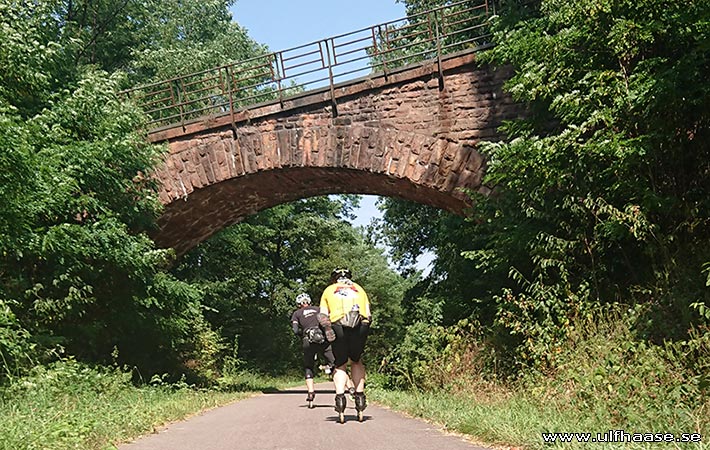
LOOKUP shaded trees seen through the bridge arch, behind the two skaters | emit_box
[176,197,407,373]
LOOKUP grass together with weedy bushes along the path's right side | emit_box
[370,314,710,450]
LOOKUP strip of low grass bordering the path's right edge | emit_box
[369,387,710,450]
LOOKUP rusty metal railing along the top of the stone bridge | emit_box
[121,0,495,130]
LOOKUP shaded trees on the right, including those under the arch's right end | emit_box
[383,0,710,393]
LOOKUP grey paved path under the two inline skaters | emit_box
[119,383,486,450]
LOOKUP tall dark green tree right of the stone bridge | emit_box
[482,0,710,346]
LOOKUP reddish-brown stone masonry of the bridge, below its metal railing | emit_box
[150,54,522,254]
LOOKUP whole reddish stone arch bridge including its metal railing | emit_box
[131,0,522,254]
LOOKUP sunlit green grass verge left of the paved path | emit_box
[0,360,290,450]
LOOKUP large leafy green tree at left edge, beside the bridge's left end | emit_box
[0,2,195,382]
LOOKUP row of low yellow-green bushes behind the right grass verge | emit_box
[377,305,710,437]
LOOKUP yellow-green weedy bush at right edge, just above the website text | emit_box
[523,308,710,432]
